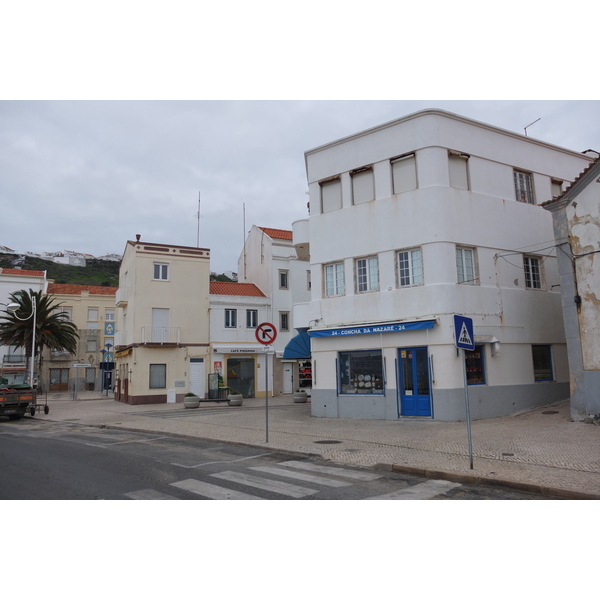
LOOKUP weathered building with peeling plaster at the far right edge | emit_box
[544,158,600,421]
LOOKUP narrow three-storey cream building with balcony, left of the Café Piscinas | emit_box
[115,237,210,404]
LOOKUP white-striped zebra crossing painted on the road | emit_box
[120,460,461,500]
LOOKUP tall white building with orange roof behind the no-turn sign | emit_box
[238,225,311,395]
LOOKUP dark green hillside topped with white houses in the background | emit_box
[0,254,121,287]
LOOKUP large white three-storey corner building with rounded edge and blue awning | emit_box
[298,110,590,421]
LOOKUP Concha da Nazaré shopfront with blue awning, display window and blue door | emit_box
[309,320,435,419]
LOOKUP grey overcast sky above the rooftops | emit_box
[0,100,600,273]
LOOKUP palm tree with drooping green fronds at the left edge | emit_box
[0,289,79,382]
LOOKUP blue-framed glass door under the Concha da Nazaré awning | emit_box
[398,348,431,417]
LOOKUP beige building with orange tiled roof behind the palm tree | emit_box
[41,283,117,392]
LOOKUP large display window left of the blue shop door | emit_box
[339,350,383,394]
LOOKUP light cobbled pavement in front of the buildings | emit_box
[21,392,600,500]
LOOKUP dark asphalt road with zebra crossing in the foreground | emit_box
[0,418,552,500]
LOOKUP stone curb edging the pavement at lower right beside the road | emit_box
[374,463,600,500]
